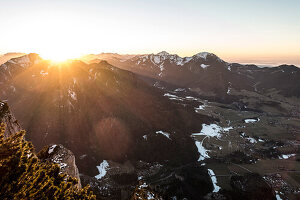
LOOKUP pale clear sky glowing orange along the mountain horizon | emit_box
[0,0,300,65]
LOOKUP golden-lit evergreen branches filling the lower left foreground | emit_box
[0,123,96,200]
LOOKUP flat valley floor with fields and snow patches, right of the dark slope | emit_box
[161,85,300,199]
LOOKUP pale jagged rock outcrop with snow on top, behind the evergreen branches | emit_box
[38,144,81,188]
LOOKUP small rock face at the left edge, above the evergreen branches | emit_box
[0,101,21,138]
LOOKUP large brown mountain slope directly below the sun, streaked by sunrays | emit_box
[0,54,209,174]
